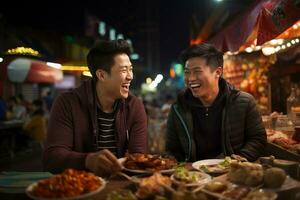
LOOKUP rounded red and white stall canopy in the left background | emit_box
[7,58,63,83]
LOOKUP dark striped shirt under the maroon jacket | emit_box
[97,108,117,155]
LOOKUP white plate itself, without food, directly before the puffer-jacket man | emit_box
[192,159,229,174]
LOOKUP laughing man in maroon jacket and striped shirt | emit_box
[43,40,147,176]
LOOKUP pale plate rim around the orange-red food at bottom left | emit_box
[26,177,106,200]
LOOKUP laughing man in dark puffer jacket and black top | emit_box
[166,44,266,161]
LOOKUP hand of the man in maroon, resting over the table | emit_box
[85,149,122,177]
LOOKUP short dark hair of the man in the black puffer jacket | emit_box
[180,43,223,69]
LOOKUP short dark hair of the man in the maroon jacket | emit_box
[87,39,131,79]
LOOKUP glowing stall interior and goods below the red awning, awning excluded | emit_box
[224,43,300,161]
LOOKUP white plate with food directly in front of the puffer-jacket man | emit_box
[192,157,232,174]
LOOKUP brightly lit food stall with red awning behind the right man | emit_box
[197,0,300,162]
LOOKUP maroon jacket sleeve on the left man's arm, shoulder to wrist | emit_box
[43,96,86,173]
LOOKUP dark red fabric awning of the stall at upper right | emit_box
[207,0,300,52]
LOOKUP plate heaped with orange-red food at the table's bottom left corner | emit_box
[26,169,106,200]
